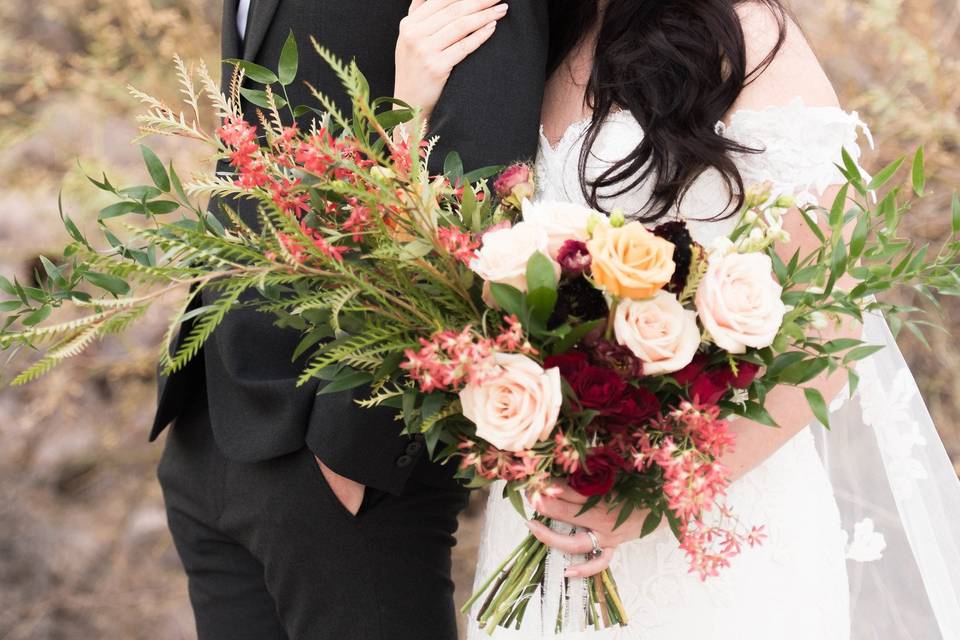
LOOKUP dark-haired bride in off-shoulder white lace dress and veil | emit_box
[456,0,960,640]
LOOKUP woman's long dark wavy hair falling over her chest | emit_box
[549,0,787,222]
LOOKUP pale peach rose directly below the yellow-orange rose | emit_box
[613,291,700,376]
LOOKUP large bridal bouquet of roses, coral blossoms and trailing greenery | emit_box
[0,38,960,633]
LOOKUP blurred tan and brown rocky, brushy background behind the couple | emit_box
[0,0,960,640]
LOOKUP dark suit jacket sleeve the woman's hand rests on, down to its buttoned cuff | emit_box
[307,0,548,492]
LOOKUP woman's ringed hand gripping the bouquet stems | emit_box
[527,483,649,578]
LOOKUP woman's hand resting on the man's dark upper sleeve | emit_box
[394,0,507,119]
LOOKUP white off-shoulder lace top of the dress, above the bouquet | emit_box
[536,98,873,245]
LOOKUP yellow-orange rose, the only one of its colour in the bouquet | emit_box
[587,222,676,299]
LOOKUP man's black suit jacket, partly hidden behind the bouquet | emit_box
[151,0,548,493]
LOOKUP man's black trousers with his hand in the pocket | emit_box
[158,393,467,640]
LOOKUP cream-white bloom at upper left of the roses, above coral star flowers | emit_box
[470,222,560,291]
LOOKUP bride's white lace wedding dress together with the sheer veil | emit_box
[468,100,960,640]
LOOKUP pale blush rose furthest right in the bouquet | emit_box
[696,253,786,353]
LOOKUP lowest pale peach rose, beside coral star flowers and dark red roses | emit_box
[460,353,563,451]
